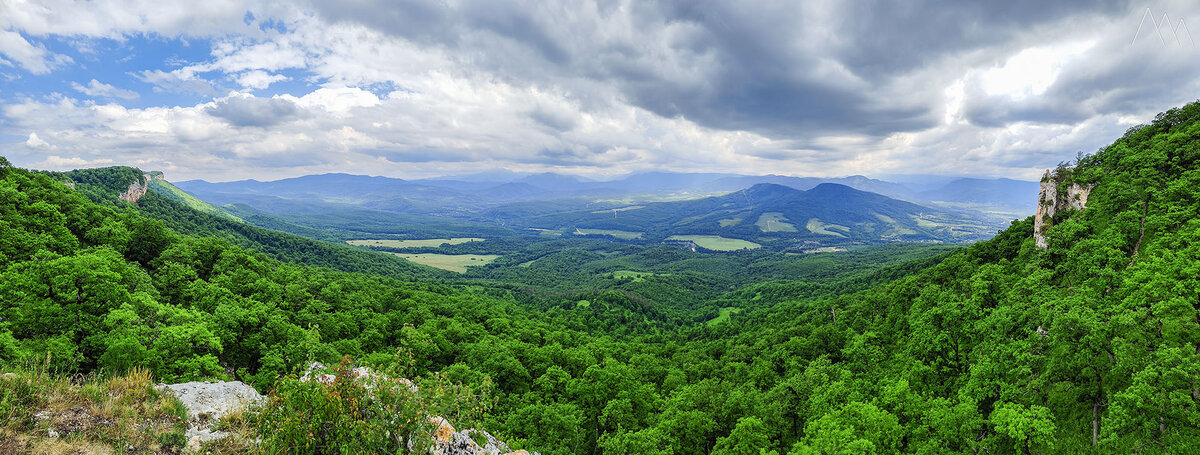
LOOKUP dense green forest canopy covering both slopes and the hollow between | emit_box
[7,99,1200,454]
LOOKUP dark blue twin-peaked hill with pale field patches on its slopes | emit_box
[511,182,1003,245]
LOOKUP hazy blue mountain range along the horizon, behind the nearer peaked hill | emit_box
[175,172,1037,217]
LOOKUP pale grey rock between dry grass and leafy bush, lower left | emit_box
[157,381,265,451]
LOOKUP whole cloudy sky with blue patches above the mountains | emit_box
[0,0,1200,181]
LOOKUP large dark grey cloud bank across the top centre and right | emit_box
[297,0,1128,138]
